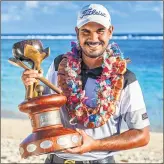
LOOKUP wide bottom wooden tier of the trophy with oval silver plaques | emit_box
[19,127,81,158]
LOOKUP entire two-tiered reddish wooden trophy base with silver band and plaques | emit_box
[19,94,82,158]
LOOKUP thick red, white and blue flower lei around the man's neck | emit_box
[58,42,127,128]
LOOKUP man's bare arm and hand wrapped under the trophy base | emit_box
[65,126,150,154]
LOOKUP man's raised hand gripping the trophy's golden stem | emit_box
[22,69,43,86]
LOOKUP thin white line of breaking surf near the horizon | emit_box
[1,34,163,40]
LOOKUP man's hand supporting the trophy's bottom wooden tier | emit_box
[63,129,99,154]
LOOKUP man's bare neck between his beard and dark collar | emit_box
[82,53,103,69]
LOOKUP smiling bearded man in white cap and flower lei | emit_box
[22,4,149,163]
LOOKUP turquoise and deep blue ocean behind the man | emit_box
[1,34,163,132]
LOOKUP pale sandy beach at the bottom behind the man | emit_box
[1,118,163,163]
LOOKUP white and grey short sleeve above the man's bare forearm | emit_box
[120,80,150,129]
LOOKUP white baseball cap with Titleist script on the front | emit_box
[77,4,111,28]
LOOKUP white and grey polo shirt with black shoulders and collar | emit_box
[45,56,150,161]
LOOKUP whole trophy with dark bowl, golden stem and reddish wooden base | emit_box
[8,40,82,158]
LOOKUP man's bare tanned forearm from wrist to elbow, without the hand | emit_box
[95,129,149,151]
